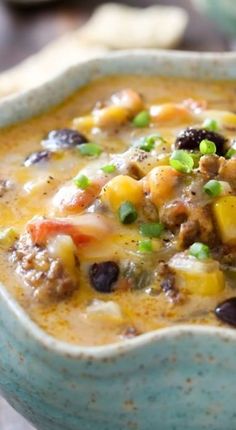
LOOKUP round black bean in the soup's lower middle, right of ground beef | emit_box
[89,261,120,293]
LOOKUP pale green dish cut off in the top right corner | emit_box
[192,0,236,36]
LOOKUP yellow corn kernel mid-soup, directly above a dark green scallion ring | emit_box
[101,175,143,211]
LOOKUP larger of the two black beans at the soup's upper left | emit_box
[42,128,88,151]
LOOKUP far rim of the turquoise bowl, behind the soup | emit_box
[0,49,236,129]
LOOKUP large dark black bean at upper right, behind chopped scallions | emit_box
[175,127,227,155]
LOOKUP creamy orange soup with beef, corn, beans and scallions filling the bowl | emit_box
[0,76,236,345]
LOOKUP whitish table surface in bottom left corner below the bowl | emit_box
[0,397,36,430]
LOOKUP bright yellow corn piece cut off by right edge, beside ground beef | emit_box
[213,196,236,245]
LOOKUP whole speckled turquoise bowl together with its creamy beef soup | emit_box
[0,53,236,430]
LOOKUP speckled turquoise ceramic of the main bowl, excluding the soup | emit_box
[0,51,236,430]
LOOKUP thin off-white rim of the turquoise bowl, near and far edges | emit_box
[0,50,236,360]
